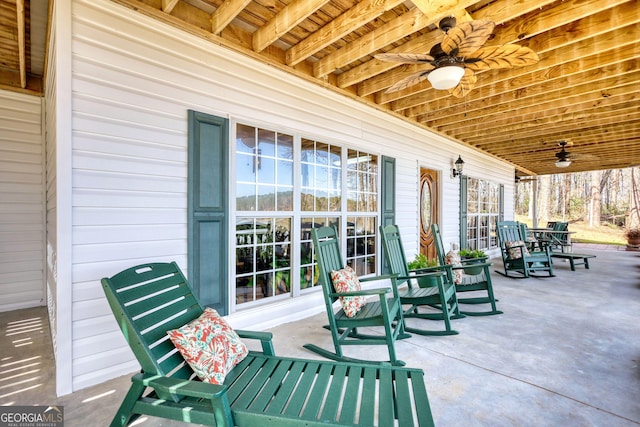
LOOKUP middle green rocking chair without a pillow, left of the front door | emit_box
[380,225,464,335]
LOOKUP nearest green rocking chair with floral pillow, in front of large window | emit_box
[304,227,411,366]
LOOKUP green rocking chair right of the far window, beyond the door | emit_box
[496,221,553,278]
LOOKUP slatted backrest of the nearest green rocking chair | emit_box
[311,227,345,309]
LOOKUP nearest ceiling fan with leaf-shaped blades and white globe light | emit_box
[375,17,539,98]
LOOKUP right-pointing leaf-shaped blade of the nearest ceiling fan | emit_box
[464,44,540,71]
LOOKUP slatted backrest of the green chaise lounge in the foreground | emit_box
[102,262,203,378]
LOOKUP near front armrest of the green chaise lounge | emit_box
[131,373,227,402]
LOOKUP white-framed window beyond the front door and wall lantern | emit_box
[466,178,502,250]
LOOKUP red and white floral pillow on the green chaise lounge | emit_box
[167,307,249,384]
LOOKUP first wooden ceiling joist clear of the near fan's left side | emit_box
[285,0,404,66]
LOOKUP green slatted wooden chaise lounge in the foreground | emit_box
[102,263,433,427]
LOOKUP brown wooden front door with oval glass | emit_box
[420,168,439,259]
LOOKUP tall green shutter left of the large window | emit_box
[187,111,229,315]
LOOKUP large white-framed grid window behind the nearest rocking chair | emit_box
[235,124,379,304]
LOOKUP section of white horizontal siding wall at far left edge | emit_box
[0,90,45,311]
